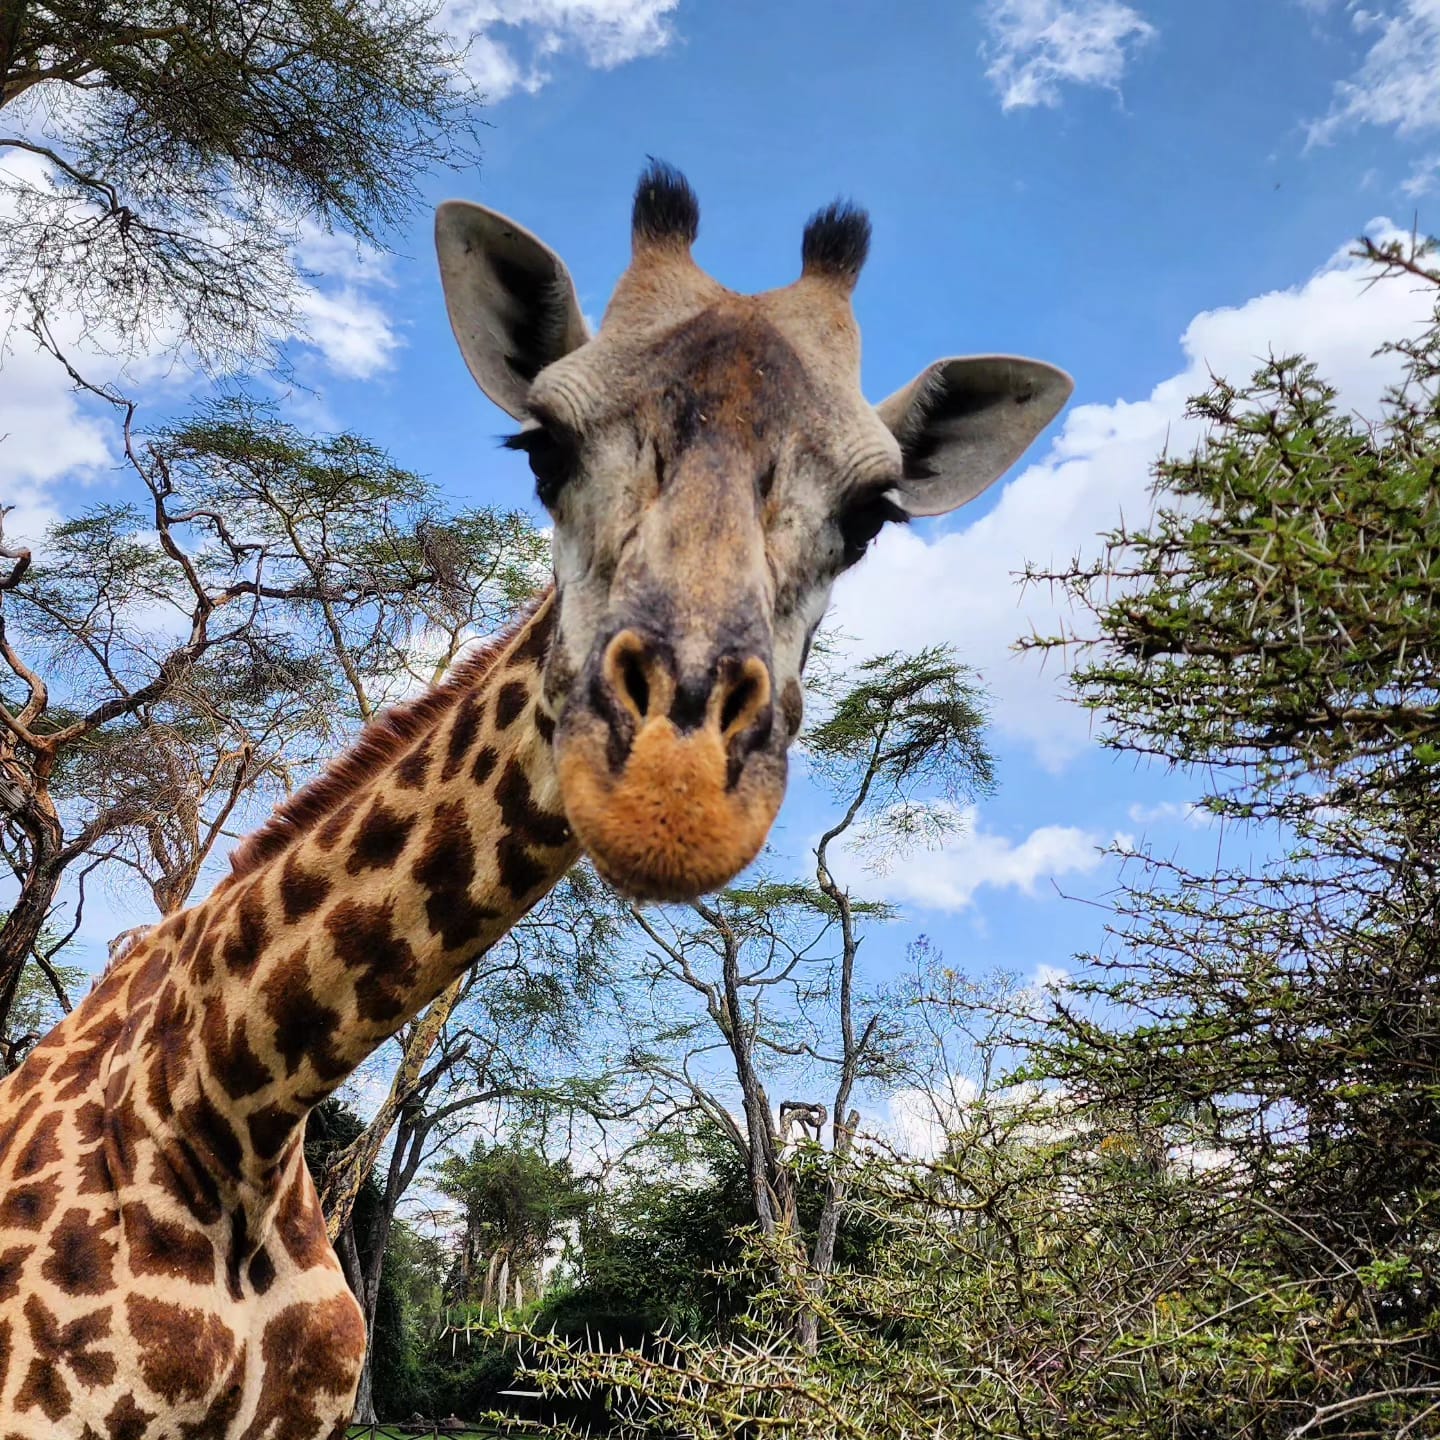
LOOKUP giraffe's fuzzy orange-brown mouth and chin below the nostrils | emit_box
[556,716,785,900]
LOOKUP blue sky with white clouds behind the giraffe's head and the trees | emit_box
[8,0,1440,1019]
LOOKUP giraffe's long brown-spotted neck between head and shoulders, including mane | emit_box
[108,595,577,1200]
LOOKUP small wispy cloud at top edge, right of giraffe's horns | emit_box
[981,0,1155,109]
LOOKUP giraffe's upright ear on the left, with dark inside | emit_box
[435,200,590,419]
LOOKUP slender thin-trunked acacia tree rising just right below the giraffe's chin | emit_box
[613,648,994,1345]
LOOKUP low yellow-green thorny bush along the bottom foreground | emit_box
[521,1106,1221,1440]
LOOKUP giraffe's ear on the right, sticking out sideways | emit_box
[876,356,1074,516]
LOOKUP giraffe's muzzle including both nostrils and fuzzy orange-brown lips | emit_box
[556,629,785,900]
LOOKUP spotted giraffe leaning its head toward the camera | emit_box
[0,163,1070,1440]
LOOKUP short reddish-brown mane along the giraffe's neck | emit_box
[230,590,550,880]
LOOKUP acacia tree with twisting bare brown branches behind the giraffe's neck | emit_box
[0,374,543,1048]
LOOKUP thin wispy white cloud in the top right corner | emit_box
[1309,0,1440,144]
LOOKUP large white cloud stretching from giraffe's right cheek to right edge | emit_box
[835,222,1431,770]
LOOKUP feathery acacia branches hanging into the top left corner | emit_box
[0,0,474,367]
